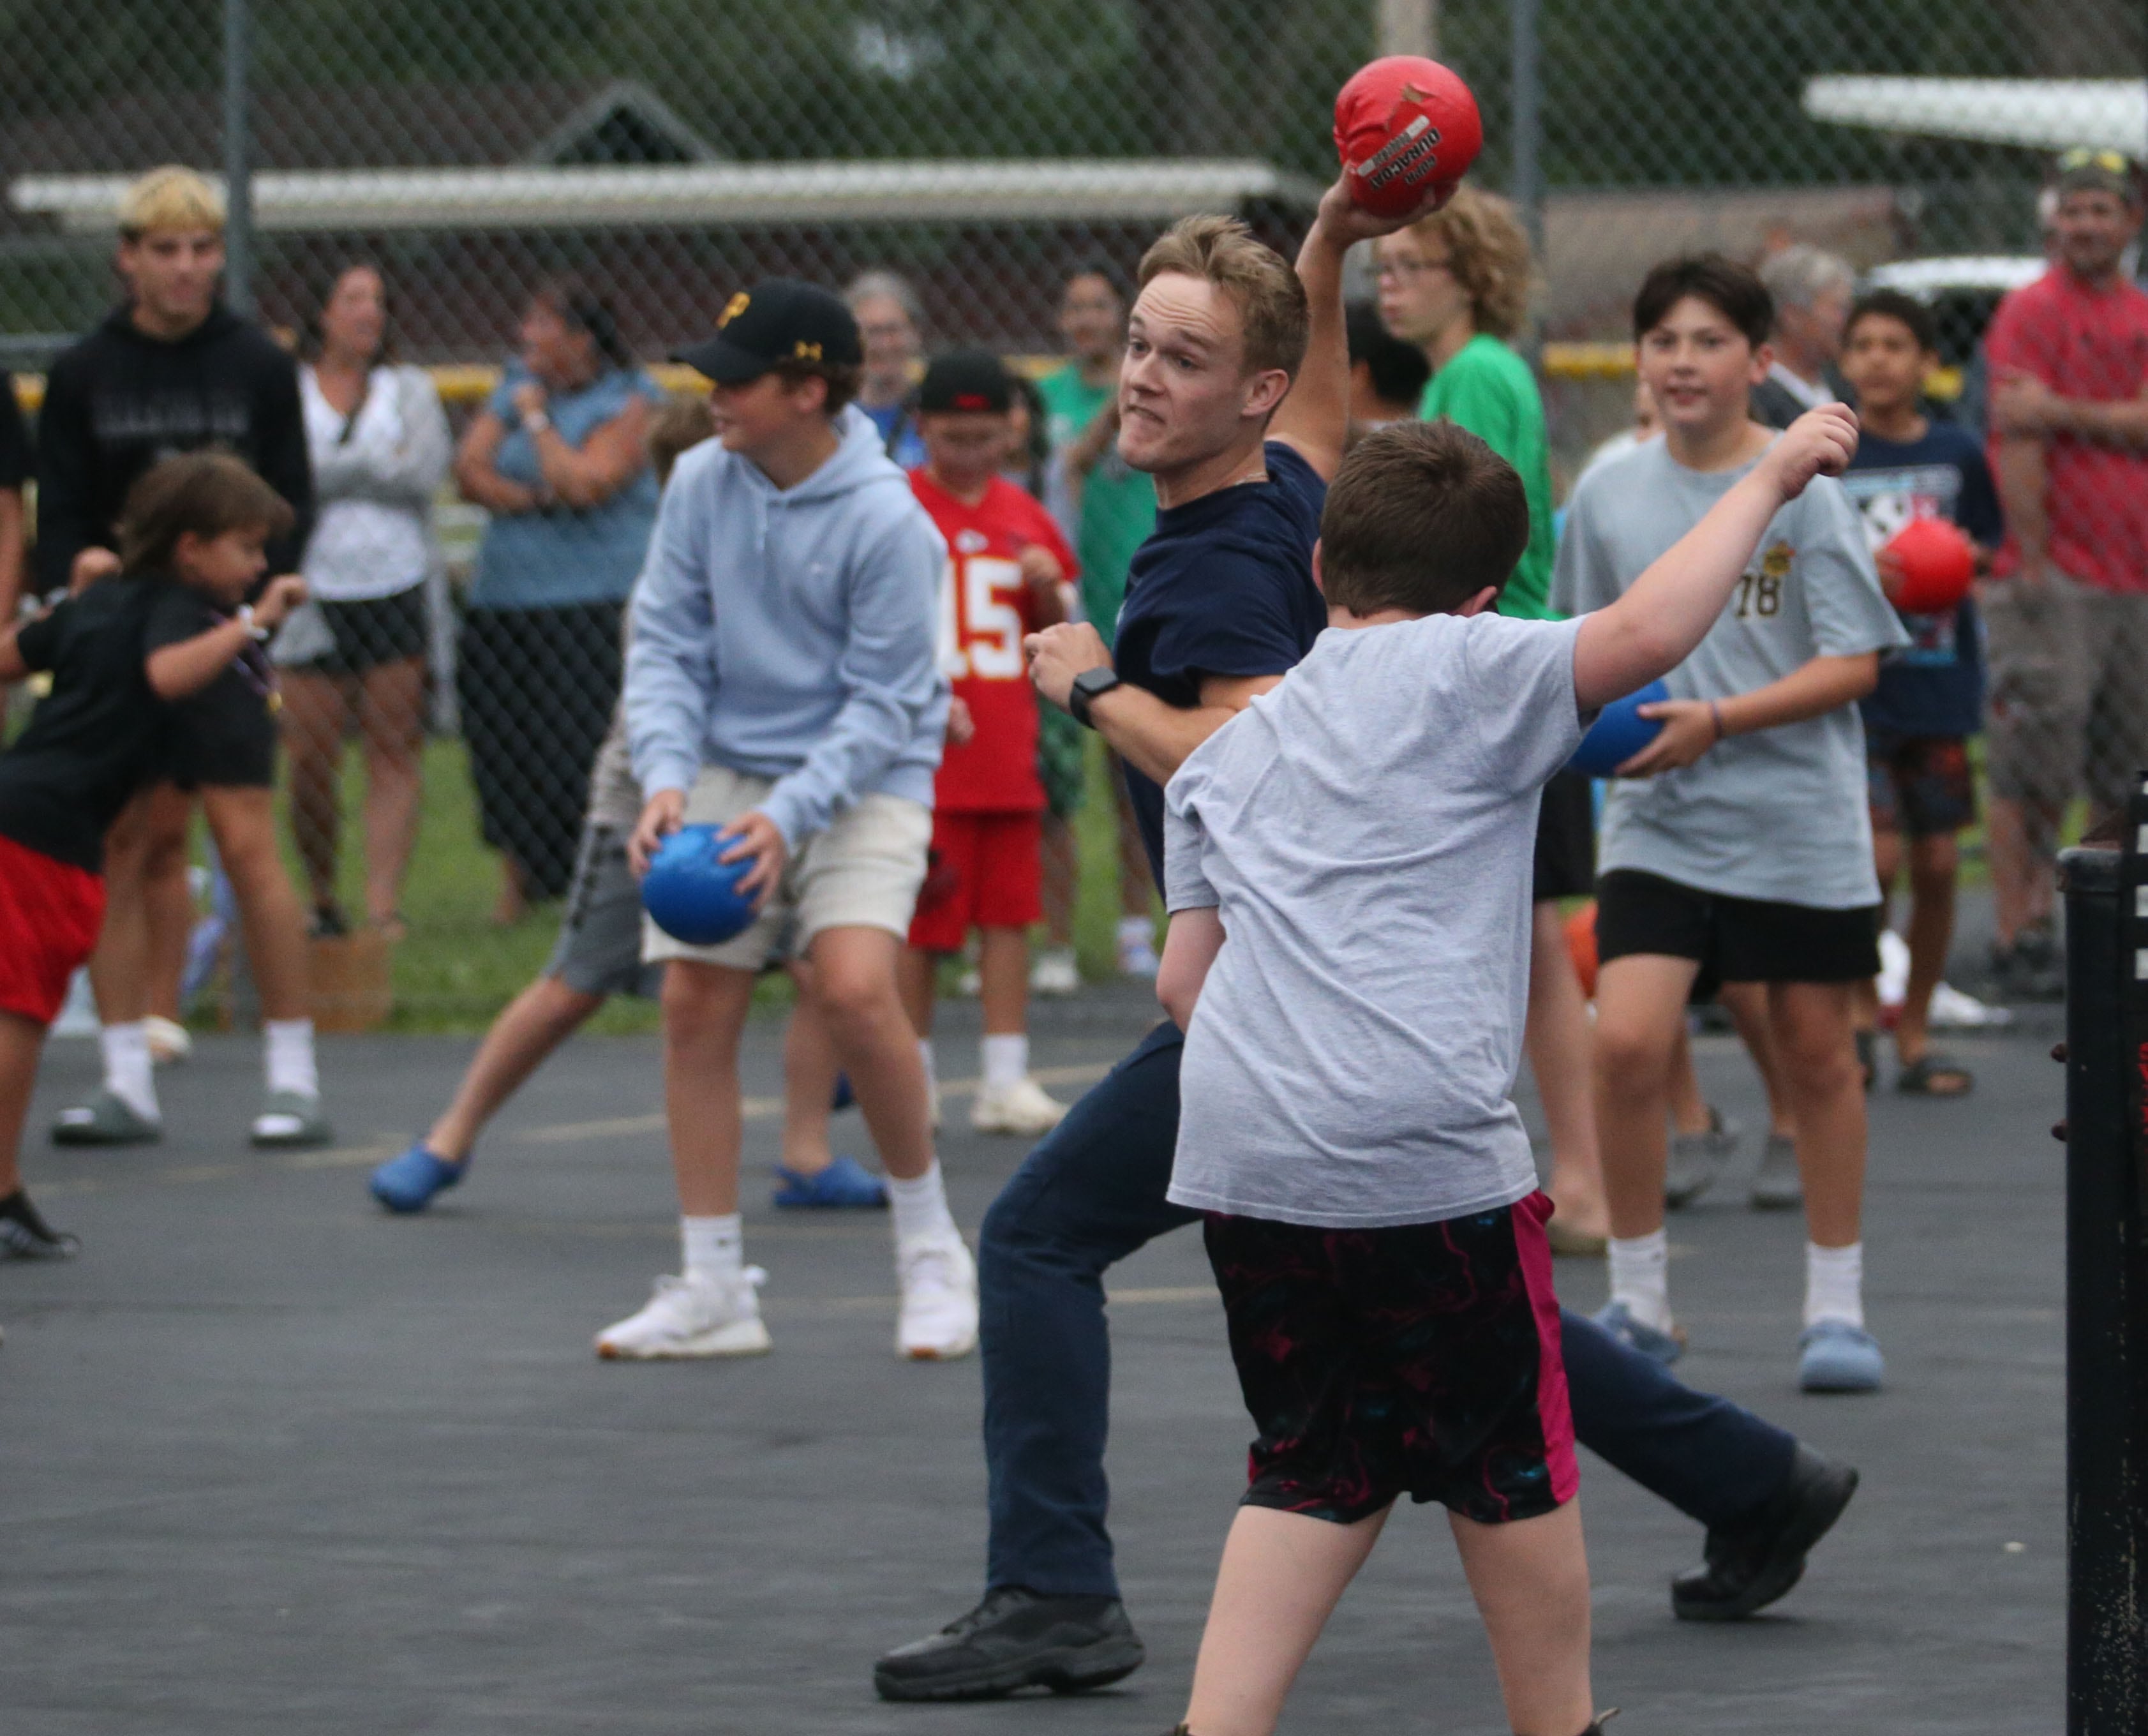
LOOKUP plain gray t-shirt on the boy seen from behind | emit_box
[1164,615,1581,1229]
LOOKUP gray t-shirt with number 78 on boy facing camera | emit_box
[1551,440,1907,911]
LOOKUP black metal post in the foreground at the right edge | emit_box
[2060,825,2148,1736]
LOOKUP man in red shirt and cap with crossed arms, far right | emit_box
[1985,151,2148,995]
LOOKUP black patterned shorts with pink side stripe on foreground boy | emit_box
[1203,1192,1577,1525]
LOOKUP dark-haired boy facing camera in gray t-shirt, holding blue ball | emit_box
[1553,256,1907,1392]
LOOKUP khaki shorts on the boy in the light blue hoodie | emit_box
[642,765,932,971]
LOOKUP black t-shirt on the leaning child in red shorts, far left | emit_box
[0,578,176,872]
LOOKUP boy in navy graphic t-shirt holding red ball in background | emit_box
[1843,290,2002,1098]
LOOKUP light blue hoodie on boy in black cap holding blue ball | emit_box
[625,406,947,851]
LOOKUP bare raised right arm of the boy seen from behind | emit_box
[1574,404,1858,711]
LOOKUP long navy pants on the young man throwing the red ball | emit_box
[978,1022,1796,1596]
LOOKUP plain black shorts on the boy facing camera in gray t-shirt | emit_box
[1596,868,1879,999]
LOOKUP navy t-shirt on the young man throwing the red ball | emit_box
[1113,440,1327,885]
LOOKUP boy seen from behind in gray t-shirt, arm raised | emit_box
[1158,406,1856,1736]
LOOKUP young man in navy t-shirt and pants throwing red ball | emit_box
[874,185,1856,1700]
